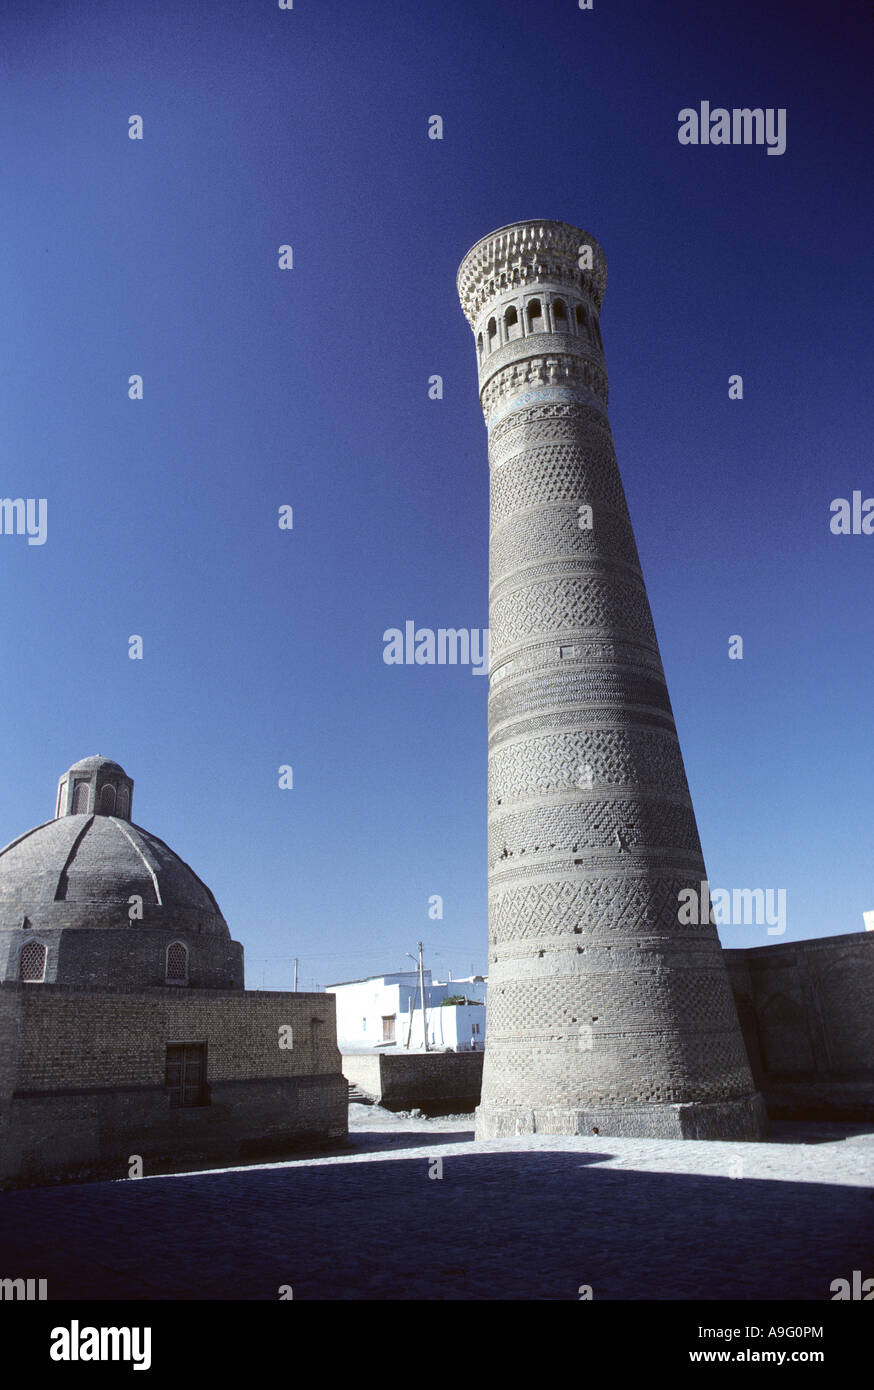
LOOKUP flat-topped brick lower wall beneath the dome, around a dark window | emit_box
[0,983,347,1184]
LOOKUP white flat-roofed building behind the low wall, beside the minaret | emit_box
[325,970,485,1052]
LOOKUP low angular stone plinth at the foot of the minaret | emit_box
[475,1091,767,1140]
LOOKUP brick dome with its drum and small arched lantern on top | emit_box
[0,756,243,990]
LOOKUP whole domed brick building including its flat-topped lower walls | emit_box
[0,755,347,1186]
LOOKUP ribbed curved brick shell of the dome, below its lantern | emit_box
[0,811,231,940]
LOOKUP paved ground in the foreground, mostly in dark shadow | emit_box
[0,1106,874,1300]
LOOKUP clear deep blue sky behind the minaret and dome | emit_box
[0,0,874,987]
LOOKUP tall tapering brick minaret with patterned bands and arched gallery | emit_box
[459,221,764,1138]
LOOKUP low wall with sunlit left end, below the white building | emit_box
[343,1051,484,1115]
